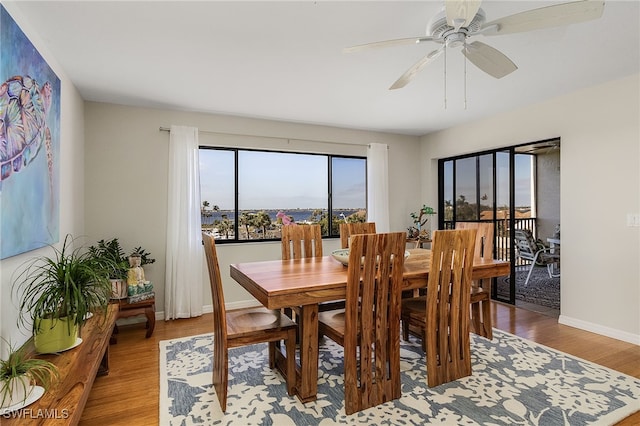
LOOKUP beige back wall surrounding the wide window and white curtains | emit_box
[85,102,422,316]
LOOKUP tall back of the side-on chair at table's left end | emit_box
[202,232,229,410]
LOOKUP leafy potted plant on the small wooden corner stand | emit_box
[89,238,156,299]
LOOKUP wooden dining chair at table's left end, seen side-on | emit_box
[202,232,297,412]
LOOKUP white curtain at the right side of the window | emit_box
[367,143,389,232]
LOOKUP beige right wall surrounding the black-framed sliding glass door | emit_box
[422,75,640,344]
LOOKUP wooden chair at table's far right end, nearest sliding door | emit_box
[456,222,494,339]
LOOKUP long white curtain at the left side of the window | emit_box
[164,126,203,320]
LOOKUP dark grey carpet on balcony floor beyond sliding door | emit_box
[496,266,560,310]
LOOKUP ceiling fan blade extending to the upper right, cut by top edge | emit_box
[481,0,604,36]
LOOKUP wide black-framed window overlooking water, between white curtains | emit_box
[200,147,367,242]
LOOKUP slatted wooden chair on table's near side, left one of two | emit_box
[318,232,406,414]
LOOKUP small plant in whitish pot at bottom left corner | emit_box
[0,344,59,408]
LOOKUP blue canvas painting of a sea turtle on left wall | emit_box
[0,5,60,259]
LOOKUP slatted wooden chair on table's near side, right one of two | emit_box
[401,229,477,387]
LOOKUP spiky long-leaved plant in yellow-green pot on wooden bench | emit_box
[13,235,114,353]
